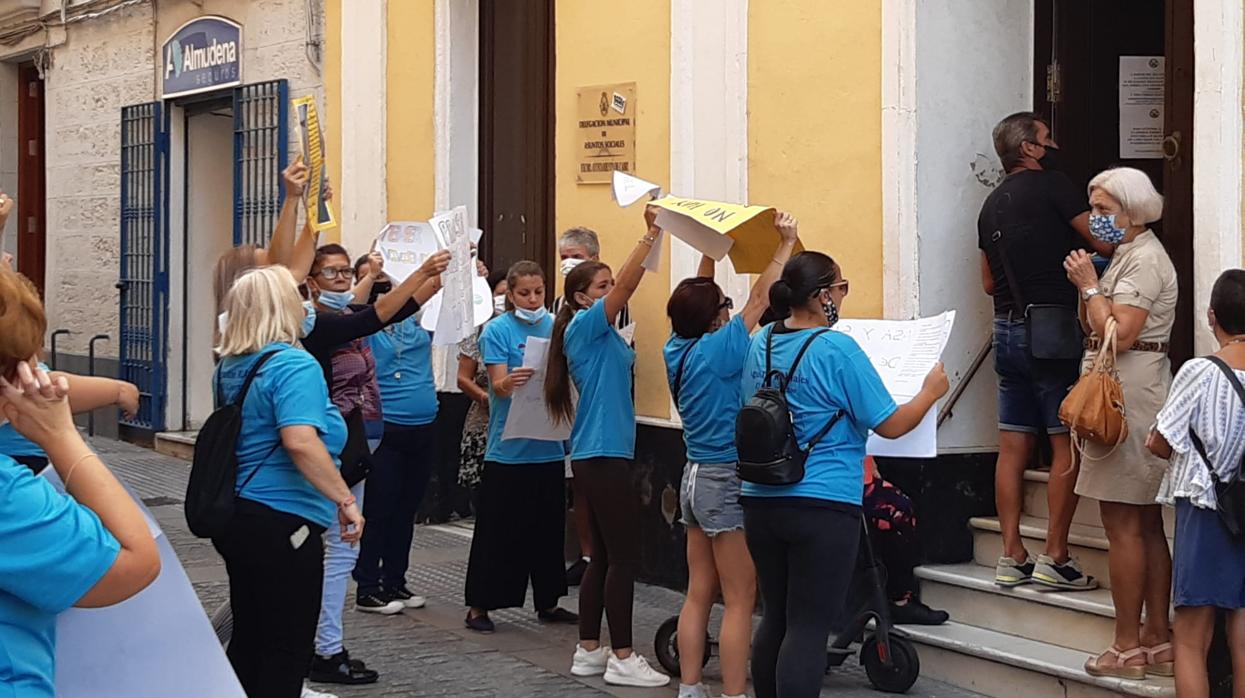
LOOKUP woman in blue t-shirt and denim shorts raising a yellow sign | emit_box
[665,212,798,698]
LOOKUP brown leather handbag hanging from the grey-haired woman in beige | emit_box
[1059,317,1128,454]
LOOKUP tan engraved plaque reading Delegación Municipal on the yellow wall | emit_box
[575,82,635,184]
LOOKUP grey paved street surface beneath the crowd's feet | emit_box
[92,439,976,698]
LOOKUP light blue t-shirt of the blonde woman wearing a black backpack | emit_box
[214,343,346,528]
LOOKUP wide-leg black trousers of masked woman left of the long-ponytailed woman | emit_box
[466,460,566,611]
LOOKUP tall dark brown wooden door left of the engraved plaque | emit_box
[479,0,554,274]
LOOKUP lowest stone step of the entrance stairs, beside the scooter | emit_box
[903,621,1175,698]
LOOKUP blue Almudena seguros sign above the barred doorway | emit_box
[161,16,242,100]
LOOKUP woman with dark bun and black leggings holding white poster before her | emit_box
[737,253,947,698]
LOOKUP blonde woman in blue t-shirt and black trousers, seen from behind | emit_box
[212,266,364,698]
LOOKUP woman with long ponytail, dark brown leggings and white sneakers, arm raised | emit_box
[544,205,670,687]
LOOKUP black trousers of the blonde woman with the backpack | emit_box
[212,500,324,698]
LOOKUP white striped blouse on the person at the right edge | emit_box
[1157,358,1245,509]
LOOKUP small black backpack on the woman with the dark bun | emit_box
[735,325,843,485]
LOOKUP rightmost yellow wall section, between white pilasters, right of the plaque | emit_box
[748,0,883,317]
